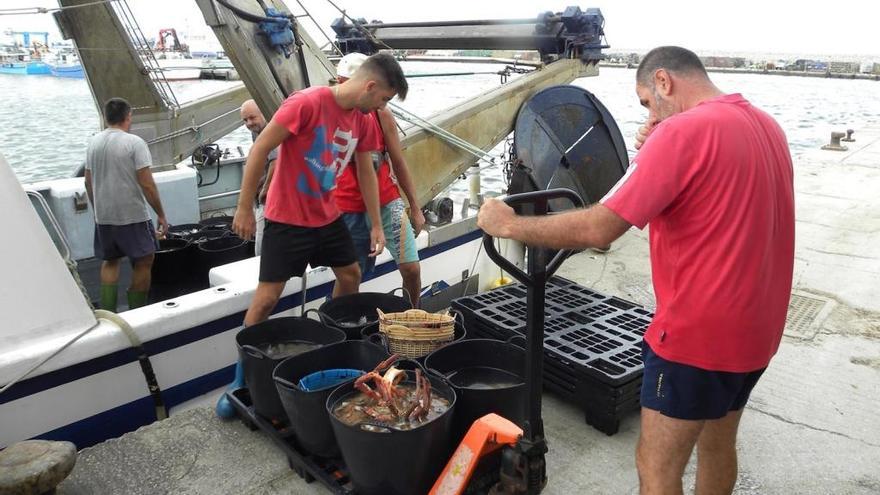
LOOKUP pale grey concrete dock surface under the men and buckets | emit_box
[58,129,880,495]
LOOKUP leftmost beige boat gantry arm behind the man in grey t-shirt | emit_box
[53,0,249,166]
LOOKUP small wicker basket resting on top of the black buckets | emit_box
[378,309,455,358]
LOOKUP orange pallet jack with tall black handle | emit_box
[430,189,583,495]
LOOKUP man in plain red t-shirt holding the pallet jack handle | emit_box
[478,47,794,493]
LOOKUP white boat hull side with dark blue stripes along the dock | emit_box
[0,231,482,449]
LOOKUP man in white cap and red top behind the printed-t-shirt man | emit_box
[333,53,425,308]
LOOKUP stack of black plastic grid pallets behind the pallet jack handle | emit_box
[452,277,653,435]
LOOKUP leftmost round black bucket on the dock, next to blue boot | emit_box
[235,316,345,423]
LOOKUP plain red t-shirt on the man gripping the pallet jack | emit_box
[601,94,794,372]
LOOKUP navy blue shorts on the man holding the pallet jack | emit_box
[641,342,766,420]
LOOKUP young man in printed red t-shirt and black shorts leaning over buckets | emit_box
[217,54,408,417]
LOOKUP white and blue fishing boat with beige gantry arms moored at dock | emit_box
[0,0,625,454]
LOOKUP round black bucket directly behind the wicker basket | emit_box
[318,292,412,340]
